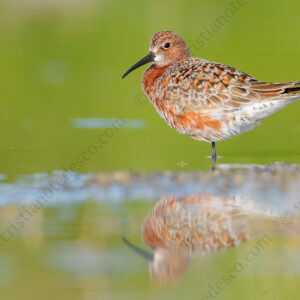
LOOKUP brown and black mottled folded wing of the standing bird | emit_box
[162,58,300,111]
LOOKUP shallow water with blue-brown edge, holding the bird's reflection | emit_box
[0,164,300,299]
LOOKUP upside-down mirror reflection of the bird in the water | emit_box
[124,195,292,283]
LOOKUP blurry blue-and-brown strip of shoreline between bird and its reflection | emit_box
[0,163,300,217]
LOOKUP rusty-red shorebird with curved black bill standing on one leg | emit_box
[122,31,300,171]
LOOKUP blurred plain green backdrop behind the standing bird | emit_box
[0,0,300,178]
